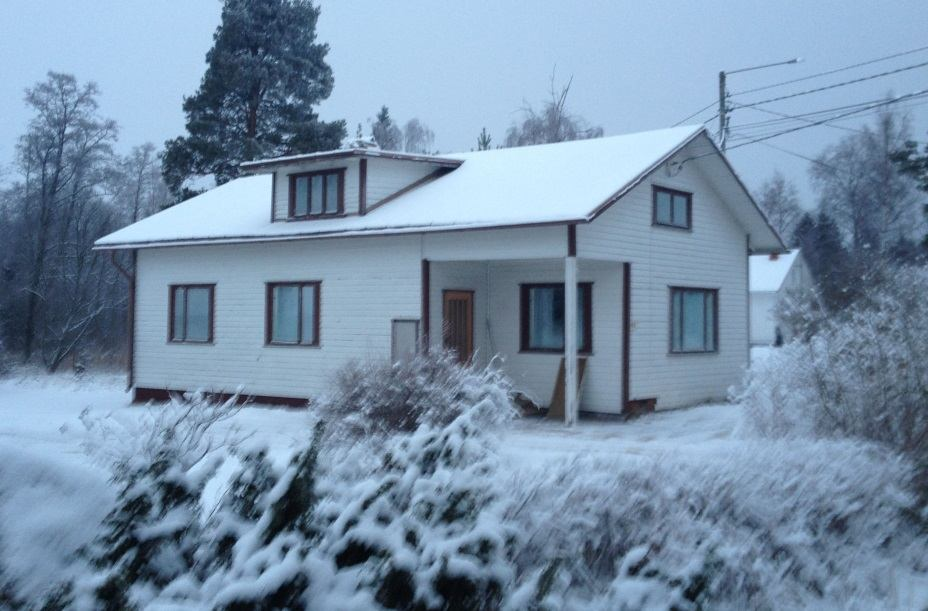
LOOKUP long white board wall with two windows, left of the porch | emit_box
[135,236,421,397]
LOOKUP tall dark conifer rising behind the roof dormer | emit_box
[162,0,346,196]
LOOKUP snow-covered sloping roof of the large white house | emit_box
[96,126,779,248]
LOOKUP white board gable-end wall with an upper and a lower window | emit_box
[577,142,748,409]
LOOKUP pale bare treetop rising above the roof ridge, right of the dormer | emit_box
[505,74,603,147]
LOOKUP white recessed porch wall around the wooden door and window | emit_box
[429,258,622,414]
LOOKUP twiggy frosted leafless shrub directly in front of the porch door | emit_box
[319,351,510,437]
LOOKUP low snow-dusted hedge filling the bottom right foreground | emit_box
[509,441,928,610]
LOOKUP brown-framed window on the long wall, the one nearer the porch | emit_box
[266,281,320,346]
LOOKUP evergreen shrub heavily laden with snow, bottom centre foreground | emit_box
[320,390,514,609]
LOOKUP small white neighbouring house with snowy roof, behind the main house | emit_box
[750,248,814,346]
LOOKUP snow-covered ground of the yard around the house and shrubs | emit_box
[0,373,928,609]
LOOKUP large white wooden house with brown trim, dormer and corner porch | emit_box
[96,127,784,418]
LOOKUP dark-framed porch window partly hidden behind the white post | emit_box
[521,282,593,352]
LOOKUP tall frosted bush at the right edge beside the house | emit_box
[735,267,928,466]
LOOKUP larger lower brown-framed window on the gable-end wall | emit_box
[670,287,719,353]
